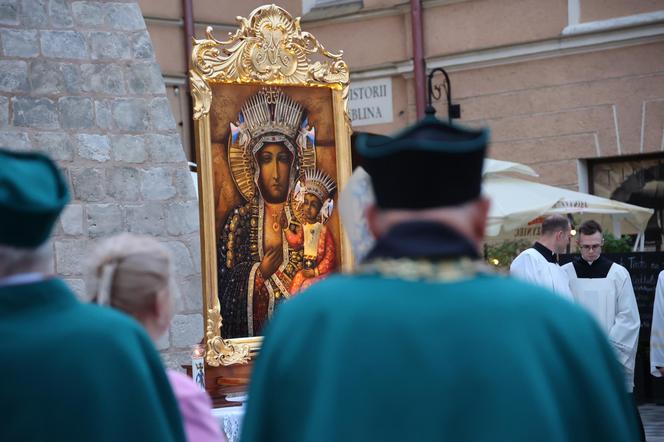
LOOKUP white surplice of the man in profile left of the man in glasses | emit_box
[510,248,572,301]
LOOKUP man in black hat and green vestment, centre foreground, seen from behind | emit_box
[242,112,638,442]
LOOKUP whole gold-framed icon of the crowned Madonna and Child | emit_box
[190,5,351,366]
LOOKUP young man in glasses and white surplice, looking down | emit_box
[563,220,645,440]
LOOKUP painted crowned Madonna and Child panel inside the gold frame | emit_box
[210,84,341,338]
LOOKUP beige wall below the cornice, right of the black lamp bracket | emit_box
[460,42,664,187]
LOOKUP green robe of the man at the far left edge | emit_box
[0,279,185,442]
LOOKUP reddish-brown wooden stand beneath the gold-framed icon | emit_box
[182,359,253,408]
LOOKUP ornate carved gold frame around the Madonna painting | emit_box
[189,5,352,367]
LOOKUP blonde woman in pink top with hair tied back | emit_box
[88,233,226,442]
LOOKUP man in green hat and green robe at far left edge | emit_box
[0,149,185,442]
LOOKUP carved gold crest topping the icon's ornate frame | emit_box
[191,5,349,119]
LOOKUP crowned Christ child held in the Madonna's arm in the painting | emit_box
[286,169,336,296]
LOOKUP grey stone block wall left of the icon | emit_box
[0,0,203,367]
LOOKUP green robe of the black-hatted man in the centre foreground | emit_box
[242,274,639,442]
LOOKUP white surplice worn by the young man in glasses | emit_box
[562,263,641,392]
